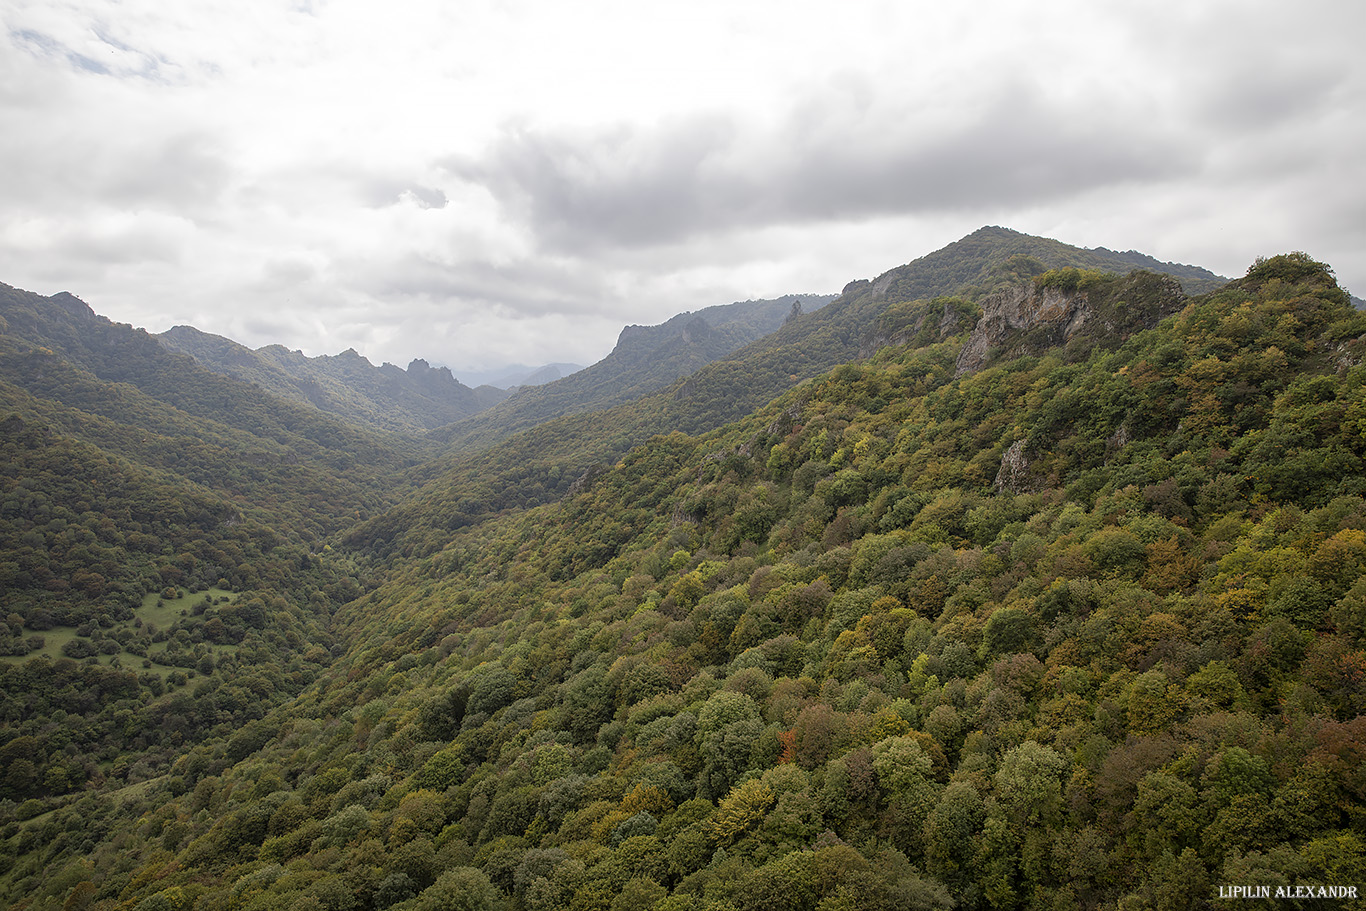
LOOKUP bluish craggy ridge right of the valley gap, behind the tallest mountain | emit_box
[430,295,833,449]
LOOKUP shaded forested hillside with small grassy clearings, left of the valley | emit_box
[0,287,422,846]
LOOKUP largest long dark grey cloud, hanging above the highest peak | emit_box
[445,85,1197,250]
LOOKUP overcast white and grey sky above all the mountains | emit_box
[0,0,1366,376]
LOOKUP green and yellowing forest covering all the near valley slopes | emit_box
[0,228,1366,911]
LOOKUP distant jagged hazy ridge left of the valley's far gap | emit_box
[156,326,505,433]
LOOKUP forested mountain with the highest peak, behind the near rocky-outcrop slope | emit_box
[351,227,1229,550]
